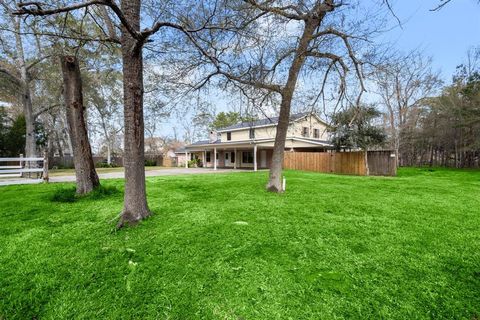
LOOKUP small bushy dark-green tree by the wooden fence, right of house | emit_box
[330,105,386,175]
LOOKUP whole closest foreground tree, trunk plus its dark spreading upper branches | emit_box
[15,0,216,227]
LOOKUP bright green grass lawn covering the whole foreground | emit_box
[0,169,480,320]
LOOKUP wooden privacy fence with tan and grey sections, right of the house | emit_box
[283,151,396,176]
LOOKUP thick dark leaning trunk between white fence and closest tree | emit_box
[61,56,100,194]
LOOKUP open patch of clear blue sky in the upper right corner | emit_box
[379,0,480,81]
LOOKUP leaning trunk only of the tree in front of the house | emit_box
[267,16,323,192]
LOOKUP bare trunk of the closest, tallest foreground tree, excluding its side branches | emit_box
[117,0,150,228]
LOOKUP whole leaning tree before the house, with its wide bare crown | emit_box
[181,0,375,192]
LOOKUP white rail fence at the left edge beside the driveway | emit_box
[0,155,48,182]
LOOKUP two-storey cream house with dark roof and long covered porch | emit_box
[182,113,332,170]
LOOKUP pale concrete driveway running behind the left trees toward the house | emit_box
[0,168,240,186]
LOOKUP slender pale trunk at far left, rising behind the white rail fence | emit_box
[12,17,37,158]
